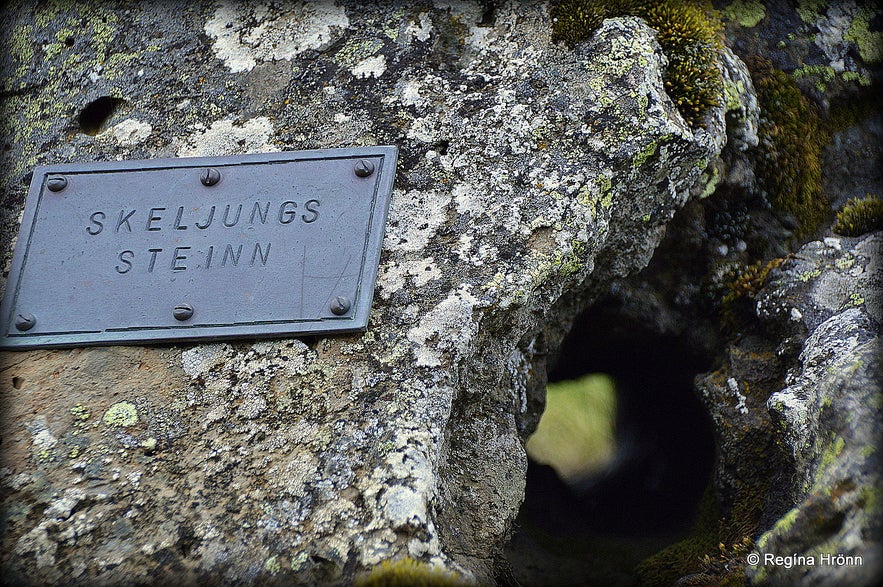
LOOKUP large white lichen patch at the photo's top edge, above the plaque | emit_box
[205,1,349,73]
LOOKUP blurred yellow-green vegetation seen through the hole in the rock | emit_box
[527,373,616,482]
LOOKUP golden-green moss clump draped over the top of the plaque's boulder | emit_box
[551,0,723,127]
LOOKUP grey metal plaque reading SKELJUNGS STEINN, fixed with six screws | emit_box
[0,146,398,349]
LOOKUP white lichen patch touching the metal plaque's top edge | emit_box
[177,116,279,157]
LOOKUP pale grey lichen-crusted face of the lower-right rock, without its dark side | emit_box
[750,232,883,585]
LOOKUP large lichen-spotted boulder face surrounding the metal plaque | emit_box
[0,2,736,584]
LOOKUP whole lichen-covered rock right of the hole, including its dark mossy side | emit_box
[698,232,883,585]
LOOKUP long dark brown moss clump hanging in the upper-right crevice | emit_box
[746,57,828,236]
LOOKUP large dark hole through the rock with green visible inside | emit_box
[507,302,715,585]
